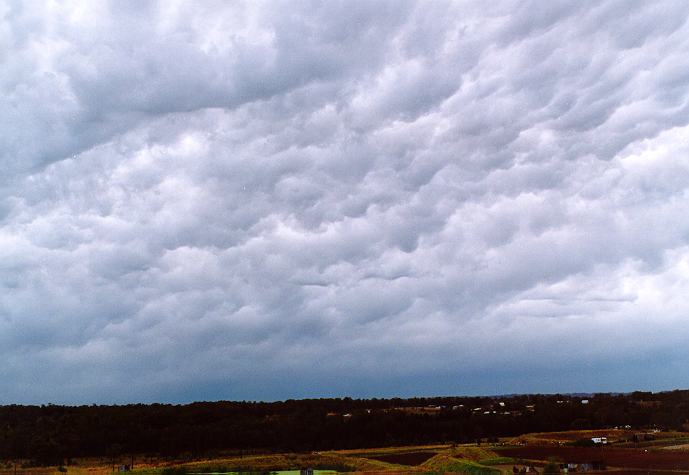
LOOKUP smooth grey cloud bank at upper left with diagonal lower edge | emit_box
[2,2,407,180]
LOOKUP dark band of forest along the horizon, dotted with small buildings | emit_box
[0,390,689,465]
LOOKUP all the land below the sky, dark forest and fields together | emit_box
[0,391,689,475]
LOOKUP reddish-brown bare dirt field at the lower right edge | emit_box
[499,446,689,473]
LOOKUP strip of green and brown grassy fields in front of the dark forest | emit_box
[5,429,689,475]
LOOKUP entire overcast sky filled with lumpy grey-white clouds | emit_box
[0,0,689,404]
